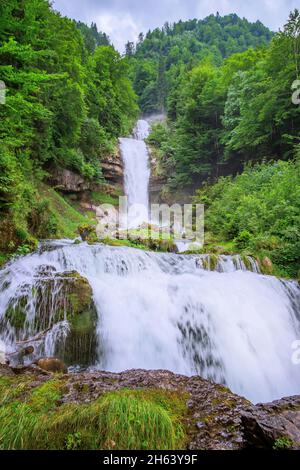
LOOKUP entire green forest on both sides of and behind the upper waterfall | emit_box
[0,0,300,276]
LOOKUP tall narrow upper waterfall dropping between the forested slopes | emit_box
[120,120,150,228]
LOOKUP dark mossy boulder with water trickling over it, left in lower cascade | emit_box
[0,266,97,366]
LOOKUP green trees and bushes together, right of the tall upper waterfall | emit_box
[144,10,300,276]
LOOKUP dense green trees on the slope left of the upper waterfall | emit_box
[0,0,138,258]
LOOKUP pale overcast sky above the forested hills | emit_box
[53,0,299,52]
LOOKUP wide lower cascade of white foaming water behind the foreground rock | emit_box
[0,241,300,402]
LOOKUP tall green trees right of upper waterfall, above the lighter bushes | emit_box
[145,10,300,190]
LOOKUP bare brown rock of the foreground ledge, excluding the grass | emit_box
[0,366,300,450]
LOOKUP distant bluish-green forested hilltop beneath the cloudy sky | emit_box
[127,15,272,113]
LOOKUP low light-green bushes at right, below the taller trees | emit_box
[195,157,300,277]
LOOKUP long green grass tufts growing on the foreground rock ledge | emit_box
[0,377,187,450]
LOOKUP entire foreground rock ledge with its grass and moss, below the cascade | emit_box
[0,366,300,450]
